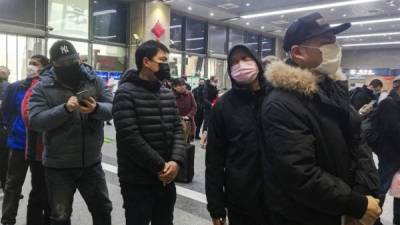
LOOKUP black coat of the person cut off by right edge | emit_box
[376,91,400,165]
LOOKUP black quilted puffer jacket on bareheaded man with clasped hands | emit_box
[113,70,184,184]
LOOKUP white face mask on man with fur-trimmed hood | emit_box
[303,43,342,75]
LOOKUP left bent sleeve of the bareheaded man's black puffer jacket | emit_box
[113,91,165,173]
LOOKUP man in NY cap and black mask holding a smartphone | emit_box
[29,40,112,225]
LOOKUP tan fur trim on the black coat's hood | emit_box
[265,61,346,96]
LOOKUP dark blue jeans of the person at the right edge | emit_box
[378,160,400,223]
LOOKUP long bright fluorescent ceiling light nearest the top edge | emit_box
[240,0,382,19]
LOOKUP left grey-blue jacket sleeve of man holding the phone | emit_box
[29,84,73,132]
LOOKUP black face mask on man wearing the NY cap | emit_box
[54,63,82,89]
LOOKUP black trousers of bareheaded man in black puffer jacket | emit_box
[121,183,176,225]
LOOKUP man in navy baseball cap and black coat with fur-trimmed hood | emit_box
[261,13,381,225]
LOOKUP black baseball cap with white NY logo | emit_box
[50,40,79,63]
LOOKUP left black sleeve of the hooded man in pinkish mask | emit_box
[206,103,228,218]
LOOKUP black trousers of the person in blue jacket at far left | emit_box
[1,150,28,224]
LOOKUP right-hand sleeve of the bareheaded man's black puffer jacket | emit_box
[171,99,185,165]
